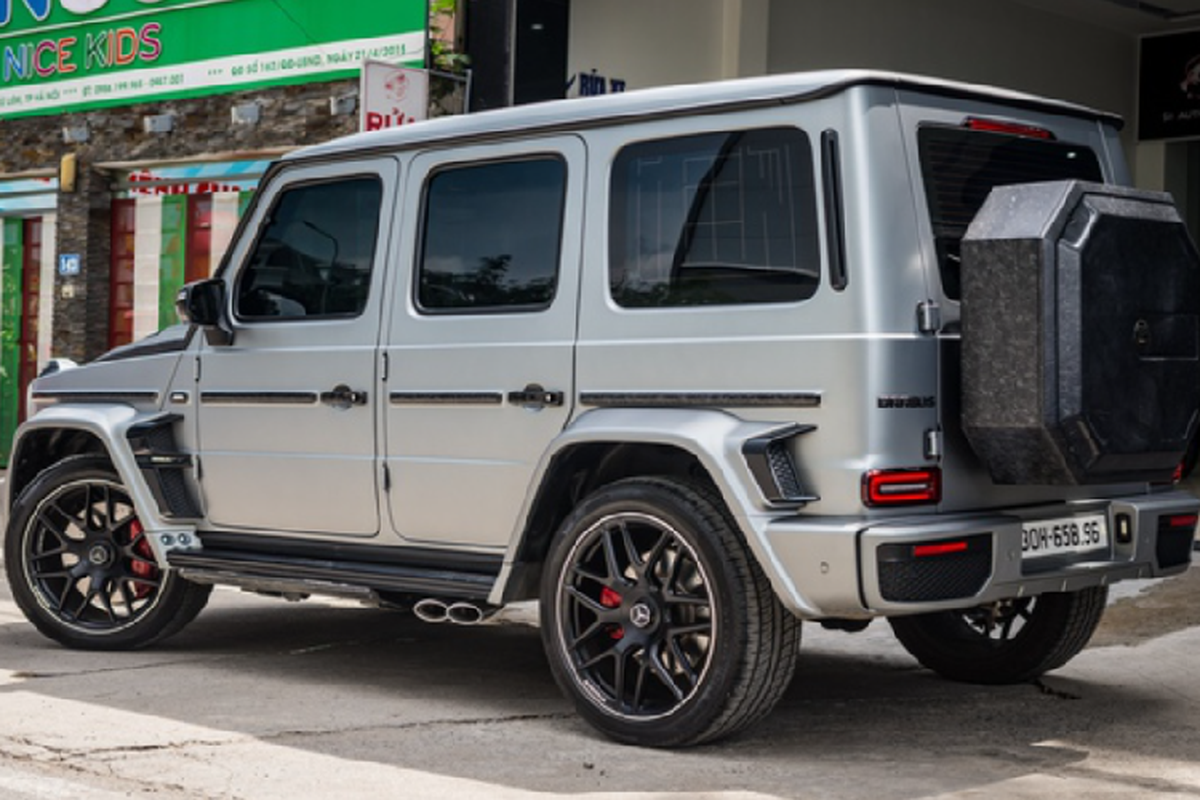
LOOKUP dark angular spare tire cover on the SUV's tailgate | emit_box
[962,181,1200,485]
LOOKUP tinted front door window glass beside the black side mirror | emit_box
[235,178,383,319]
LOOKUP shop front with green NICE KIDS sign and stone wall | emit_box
[0,0,428,467]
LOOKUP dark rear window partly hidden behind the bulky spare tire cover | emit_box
[917,125,1103,300]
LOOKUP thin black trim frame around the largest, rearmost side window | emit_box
[604,122,826,313]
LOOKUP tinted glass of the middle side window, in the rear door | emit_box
[416,156,566,313]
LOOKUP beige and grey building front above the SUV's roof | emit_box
[568,0,1200,209]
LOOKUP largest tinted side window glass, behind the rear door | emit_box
[608,127,821,307]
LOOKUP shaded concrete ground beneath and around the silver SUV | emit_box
[0,571,1200,800]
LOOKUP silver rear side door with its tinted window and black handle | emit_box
[384,137,584,548]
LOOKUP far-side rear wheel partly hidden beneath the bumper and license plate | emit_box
[888,587,1108,684]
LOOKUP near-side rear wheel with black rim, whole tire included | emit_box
[541,479,800,747]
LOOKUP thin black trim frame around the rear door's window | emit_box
[409,150,571,318]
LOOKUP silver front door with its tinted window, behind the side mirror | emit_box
[197,158,397,536]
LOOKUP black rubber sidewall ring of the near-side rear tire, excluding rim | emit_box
[540,480,748,746]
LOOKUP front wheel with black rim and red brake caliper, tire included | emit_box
[4,456,212,650]
